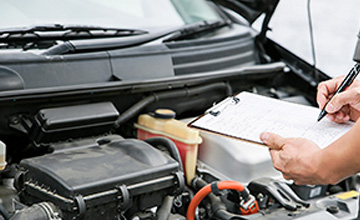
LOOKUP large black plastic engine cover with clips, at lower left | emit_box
[15,139,183,220]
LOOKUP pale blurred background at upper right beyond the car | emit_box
[255,0,360,77]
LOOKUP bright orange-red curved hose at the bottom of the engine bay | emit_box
[186,181,255,220]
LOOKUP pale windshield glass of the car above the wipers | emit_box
[0,0,220,31]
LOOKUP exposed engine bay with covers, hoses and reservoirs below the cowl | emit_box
[2,68,358,219]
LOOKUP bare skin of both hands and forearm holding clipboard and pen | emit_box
[260,77,360,185]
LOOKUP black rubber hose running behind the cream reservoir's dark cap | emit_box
[114,82,232,128]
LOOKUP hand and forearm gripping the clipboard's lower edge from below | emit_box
[260,120,360,185]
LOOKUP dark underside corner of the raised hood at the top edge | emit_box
[212,0,279,24]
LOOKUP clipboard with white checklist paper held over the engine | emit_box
[188,92,353,148]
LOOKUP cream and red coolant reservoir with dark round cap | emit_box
[135,109,202,184]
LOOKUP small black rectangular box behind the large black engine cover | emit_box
[29,102,119,144]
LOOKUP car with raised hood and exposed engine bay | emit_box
[0,0,359,220]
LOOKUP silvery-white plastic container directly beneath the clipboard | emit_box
[198,132,281,184]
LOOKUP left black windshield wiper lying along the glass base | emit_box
[0,24,148,42]
